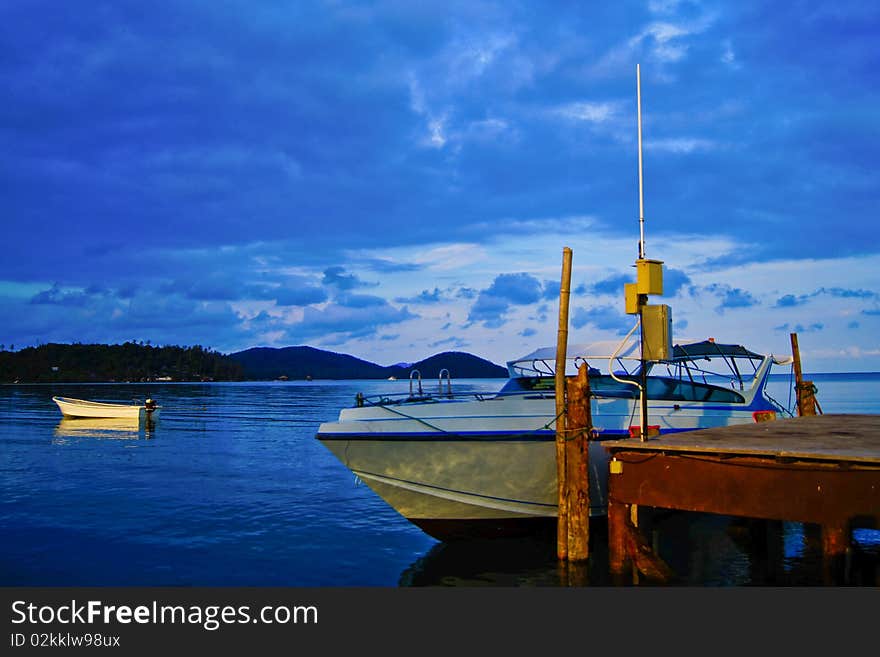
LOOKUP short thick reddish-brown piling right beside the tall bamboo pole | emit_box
[565,363,593,561]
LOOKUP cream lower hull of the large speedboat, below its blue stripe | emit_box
[321,434,608,539]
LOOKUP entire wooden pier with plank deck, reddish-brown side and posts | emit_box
[603,415,880,584]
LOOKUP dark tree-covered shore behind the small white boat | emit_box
[0,342,244,383]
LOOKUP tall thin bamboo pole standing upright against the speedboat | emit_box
[555,246,571,560]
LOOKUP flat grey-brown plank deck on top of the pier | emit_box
[602,415,880,465]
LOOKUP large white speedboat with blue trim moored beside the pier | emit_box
[317,340,791,539]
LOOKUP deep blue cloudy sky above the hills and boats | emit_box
[0,0,880,375]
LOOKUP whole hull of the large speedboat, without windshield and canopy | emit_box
[317,398,754,540]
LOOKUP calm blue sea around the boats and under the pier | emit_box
[0,375,880,586]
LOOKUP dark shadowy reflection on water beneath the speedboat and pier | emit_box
[398,510,880,586]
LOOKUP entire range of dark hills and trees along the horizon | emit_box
[0,342,507,383]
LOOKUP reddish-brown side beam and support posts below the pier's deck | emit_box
[608,441,880,584]
